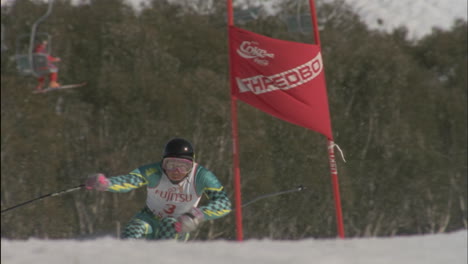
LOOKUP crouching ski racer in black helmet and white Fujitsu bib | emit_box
[86,138,231,240]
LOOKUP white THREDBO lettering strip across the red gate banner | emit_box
[236,51,323,94]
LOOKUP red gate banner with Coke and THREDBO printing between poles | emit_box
[229,26,333,139]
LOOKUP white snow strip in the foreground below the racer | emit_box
[1,230,467,264]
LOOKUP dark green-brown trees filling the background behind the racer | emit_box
[1,0,468,240]
